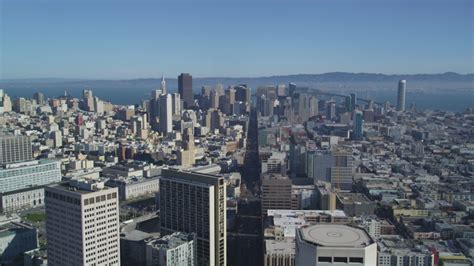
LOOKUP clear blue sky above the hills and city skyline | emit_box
[0,0,474,79]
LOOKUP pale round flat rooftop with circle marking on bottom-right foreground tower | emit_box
[300,224,373,247]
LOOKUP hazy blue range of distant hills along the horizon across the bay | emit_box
[0,72,474,94]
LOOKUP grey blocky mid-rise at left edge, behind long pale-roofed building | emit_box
[0,136,33,165]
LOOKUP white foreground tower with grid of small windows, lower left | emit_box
[45,180,120,266]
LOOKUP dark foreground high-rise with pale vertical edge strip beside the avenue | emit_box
[160,169,227,266]
